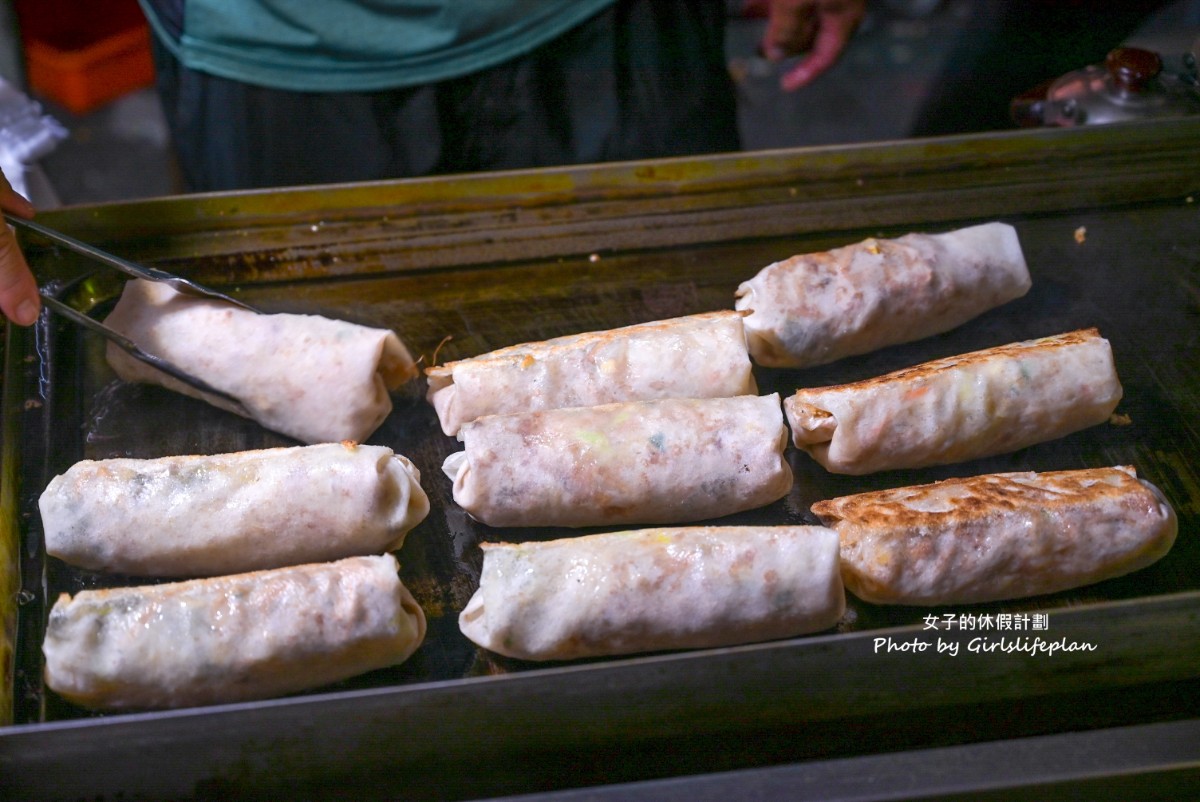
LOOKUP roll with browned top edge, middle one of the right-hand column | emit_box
[784,329,1122,474]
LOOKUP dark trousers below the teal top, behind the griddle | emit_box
[145,0,739,192]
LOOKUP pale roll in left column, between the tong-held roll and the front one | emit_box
[38,443,430,576]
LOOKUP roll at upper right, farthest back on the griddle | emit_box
[734,223,1031,367]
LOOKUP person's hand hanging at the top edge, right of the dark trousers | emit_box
[744,0,866,91]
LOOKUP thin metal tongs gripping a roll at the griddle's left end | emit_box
[12,215,258,417]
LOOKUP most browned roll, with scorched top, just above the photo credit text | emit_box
[812,467,1178,605]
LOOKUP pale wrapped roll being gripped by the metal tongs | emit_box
[104,279,419,443]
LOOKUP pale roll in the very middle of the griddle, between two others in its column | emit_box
[443,394,792,526]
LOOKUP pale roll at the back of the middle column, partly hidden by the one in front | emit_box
[425,311,757,435]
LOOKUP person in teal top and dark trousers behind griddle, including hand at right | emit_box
[140,0,864,191]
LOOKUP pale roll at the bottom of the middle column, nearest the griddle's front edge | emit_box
[458,526,846,660]
